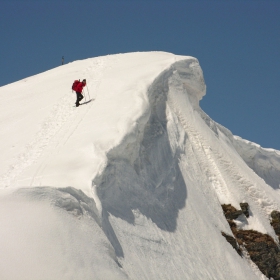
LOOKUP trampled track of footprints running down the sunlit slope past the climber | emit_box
[0,57,111,188]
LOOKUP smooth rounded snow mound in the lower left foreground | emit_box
[0,187,127,280]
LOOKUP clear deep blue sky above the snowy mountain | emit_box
[0,0,280,150]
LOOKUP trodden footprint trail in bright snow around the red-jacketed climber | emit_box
[0,56,117,188]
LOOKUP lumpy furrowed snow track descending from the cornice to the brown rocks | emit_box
[169,86,280,232]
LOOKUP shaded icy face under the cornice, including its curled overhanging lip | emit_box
[93,58,205,234]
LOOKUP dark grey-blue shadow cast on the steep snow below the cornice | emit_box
[93,71,187,257]
